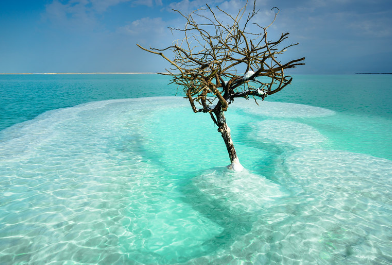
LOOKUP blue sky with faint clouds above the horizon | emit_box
[0,0,392,74]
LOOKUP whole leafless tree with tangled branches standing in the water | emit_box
[137,0,305,170]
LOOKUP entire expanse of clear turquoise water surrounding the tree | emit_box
[0,75,392,264]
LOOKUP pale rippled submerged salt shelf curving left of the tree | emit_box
[0,98,221,264]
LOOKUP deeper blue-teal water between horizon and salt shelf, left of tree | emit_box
[0,75,177,130]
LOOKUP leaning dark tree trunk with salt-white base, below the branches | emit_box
[216,110,244,171]
